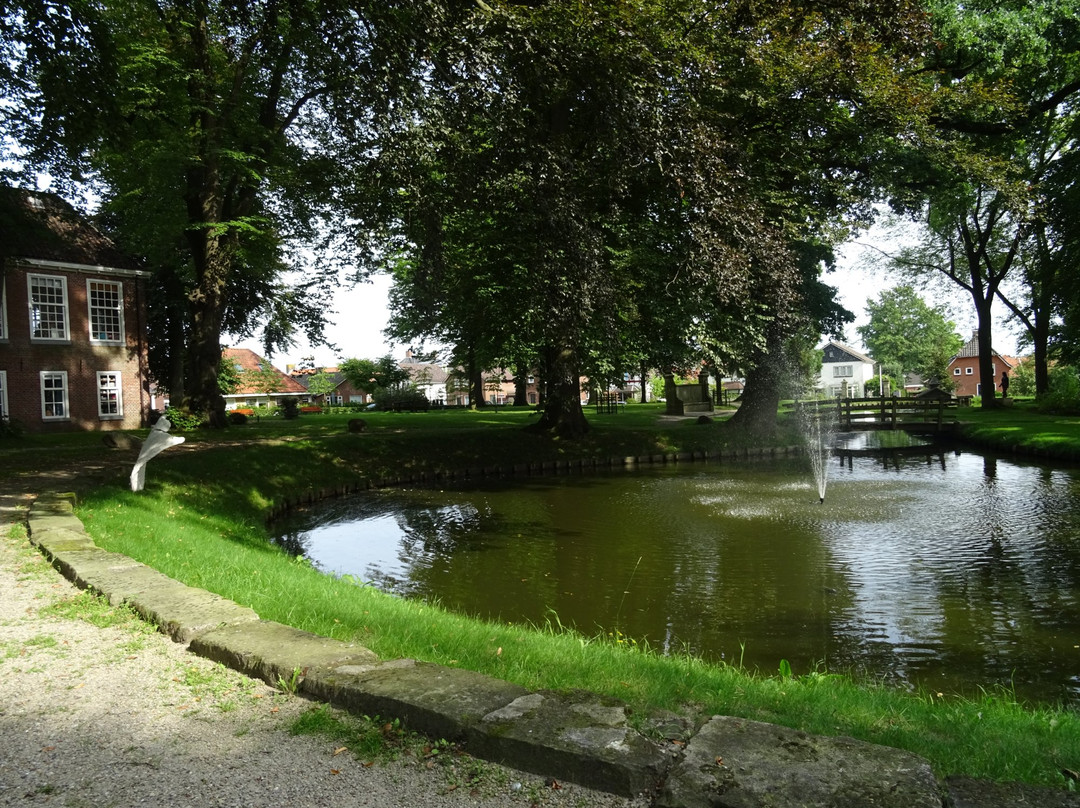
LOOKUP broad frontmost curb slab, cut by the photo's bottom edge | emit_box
[656,716,943,808]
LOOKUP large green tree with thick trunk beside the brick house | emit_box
[0,0,412,425]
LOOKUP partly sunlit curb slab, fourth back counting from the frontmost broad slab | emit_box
[189,612,378,687]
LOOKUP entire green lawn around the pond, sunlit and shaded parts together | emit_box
[0,405,1080,787]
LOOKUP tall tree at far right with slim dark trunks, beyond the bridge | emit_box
[881,0,1080,406]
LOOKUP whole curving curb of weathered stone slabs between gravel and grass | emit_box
[21,495,1080,808]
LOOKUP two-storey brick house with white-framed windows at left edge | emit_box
[0,185,150,432]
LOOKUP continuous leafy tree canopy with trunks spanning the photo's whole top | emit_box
[6,0,1080,435]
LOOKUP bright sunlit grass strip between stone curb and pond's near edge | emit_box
[79,471,1080,785]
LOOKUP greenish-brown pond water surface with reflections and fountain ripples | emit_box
[272,447,1080,701]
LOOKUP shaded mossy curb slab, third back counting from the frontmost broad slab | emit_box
[302,659,528,740]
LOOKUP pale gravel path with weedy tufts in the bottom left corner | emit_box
[0,483,647,808]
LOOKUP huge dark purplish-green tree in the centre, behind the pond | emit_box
[380,0,921,434]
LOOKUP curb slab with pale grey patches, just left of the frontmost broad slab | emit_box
[468,690,675,797]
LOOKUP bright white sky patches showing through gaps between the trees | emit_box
[230,229,1016,369]
